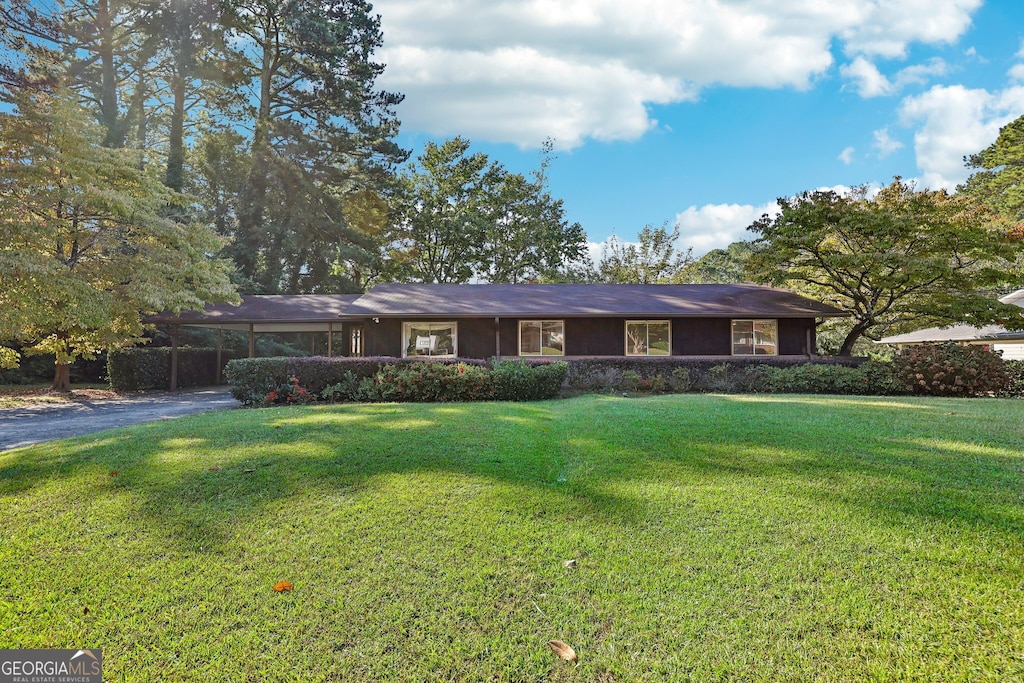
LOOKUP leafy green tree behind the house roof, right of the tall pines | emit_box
[384,137,587,283]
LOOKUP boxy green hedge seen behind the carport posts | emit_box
[106,346,217,391]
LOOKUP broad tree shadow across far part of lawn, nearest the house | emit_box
[0,396,1024,552]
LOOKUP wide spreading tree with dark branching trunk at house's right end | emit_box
[748,178,1024,355]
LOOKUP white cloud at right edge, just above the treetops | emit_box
[900,85,1024,189]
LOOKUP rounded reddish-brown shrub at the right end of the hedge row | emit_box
[893,343,1011,396]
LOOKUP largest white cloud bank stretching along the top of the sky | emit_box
[375,0,980,147]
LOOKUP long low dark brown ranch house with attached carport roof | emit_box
[148,284,846,358]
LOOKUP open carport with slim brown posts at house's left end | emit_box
[145,294,362,391]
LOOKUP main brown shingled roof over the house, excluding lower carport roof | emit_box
[345,285,847,318]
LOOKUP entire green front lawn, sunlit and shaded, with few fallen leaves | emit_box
[0,395,1024,681]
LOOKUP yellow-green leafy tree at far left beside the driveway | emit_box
[0,83,236,389]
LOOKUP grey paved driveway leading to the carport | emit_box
[0,387,239,451]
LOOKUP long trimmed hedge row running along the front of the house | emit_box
[225,357,1024,405]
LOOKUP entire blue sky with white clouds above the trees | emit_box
[375,0,1024,255]
